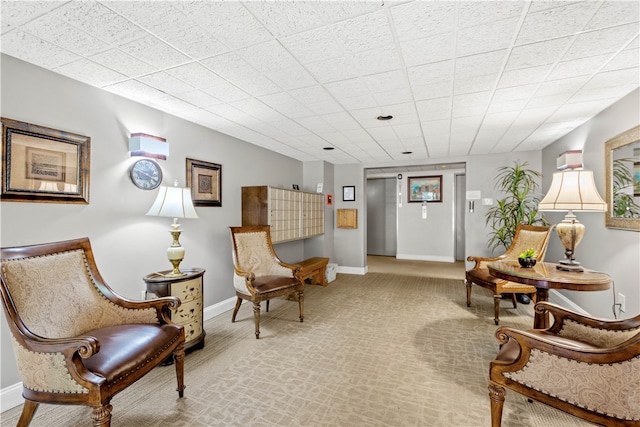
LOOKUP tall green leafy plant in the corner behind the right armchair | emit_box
[486,161,548,249]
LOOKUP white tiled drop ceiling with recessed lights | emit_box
[0,0,640,164]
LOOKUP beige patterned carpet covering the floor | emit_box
[1,273,592,427]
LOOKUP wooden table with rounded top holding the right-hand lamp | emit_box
[487,260,611,329]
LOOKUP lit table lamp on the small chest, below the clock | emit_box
[147,181,198,277]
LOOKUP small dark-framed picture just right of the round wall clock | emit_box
[187,158,222,206]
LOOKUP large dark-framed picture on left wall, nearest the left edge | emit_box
[0,117,91,204]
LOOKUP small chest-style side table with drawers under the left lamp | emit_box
[143,268,205,350]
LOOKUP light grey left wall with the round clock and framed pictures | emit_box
[0,55,308,388]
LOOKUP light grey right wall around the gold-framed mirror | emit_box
[542,89,640,318]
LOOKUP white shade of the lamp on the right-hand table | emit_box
[538,170,607,212]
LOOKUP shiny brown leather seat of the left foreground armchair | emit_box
[84,324,183,382]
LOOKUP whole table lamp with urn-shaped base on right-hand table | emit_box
[538,170,607,271]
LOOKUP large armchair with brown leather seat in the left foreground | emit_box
[0,238,185,426]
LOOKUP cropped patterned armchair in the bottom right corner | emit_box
[489,302,640,427]
